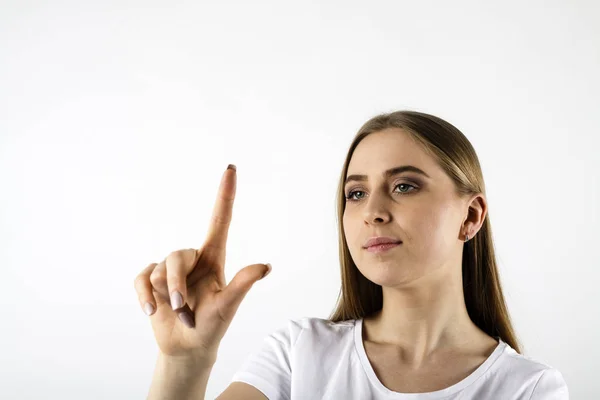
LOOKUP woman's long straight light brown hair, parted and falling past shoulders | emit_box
[328,111,521,353]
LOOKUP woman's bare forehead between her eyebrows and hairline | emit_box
[347,128,440,178]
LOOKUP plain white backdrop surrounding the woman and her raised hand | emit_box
[0,0,600,400]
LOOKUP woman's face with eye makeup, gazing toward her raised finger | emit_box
[343,128,476,286]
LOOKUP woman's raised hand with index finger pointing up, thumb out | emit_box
[134,165,271,360]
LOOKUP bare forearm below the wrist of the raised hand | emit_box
[147,352,214,400]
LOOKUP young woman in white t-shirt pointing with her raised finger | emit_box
[136,111,568,400]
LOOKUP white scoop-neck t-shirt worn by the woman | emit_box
[231,317,569,400]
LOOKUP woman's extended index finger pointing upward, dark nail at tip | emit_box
[204,164,237,251]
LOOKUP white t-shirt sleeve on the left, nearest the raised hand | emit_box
[231,320,302,400]
